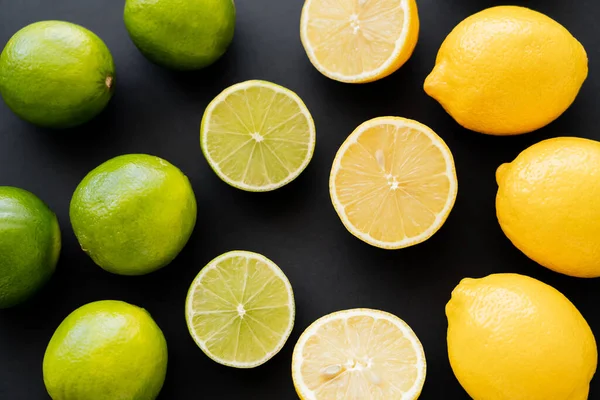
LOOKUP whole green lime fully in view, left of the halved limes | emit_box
[70,154,196,275]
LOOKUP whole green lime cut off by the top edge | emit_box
[124,0,235,70]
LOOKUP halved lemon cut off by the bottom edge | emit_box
[292,309,426,400]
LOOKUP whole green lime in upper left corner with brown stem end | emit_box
[0,21,115,128]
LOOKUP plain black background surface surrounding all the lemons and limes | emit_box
[0,0,600,400]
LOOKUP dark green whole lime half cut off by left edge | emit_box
[0,186,60,308]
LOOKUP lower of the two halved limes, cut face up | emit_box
[185,251,296,368]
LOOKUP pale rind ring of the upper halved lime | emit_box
[200,80,316,192]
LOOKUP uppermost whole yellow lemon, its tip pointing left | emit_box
[425,6,588,135]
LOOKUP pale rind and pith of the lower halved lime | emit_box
[185,250,296,369]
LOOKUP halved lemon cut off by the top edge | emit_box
[300,0,419,83]
